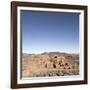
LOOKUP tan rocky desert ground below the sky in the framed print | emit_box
[21,52,79,77]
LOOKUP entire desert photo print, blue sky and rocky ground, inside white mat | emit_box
[20,10,80,78]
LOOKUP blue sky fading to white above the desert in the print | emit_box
[21,10,79,53]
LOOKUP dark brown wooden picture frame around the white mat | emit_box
[11,1,88,89]
